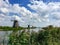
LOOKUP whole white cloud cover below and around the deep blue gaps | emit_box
[0,0,60,25]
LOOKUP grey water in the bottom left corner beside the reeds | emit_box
[0,31,12,45]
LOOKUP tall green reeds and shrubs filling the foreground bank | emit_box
[8,25,60,45]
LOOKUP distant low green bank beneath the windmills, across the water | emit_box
[0,26,36,31]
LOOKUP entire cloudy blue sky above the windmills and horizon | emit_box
[0,0,60,27]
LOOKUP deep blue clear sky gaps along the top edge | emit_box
[9,0,60,11]
